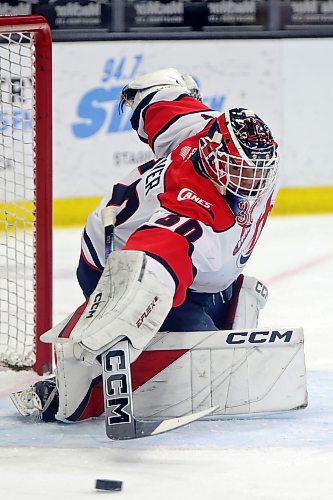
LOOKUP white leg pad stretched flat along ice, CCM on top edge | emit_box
[131,328,307,419]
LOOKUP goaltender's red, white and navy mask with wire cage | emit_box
[199,108,279,198]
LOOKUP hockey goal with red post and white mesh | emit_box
[0,16,52,374]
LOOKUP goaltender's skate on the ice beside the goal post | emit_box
[10,376,59,422]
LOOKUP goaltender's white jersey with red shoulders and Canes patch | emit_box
[82,90,277,306]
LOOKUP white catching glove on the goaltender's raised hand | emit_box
[120,68,201,111]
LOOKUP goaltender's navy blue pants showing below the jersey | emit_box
[77,256,233,332]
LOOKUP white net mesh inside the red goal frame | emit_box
[0,33,35,367]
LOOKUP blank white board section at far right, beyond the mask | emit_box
[281,39,333,186]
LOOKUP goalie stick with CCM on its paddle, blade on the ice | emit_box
[101,206,218,440]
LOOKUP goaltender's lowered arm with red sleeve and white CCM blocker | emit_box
[42,203,202,356]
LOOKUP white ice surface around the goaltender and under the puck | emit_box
[0,215,333,500]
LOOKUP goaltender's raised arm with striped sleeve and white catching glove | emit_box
[121,68,218,157]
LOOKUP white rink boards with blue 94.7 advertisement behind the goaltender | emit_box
[53,39,333,198]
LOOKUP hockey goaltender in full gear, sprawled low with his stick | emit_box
[12,68,307,439]
